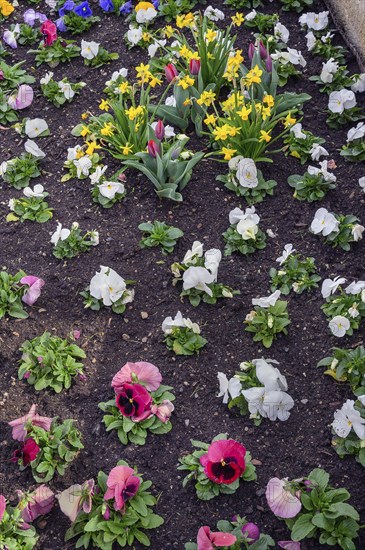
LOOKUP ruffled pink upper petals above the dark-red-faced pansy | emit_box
[112,361,162,393]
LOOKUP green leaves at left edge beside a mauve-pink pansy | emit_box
[0,269,28,319]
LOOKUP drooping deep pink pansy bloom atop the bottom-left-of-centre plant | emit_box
[104,466,141,513]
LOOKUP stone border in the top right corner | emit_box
[324,0,365,71]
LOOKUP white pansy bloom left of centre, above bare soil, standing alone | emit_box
[90,265,126,306]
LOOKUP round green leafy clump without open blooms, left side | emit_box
[18,332,86,393]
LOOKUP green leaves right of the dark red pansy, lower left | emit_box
[21,417,84,483]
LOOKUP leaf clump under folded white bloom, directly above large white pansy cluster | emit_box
[244,300,290,348]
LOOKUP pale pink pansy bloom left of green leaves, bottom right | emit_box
[266,477,302,519]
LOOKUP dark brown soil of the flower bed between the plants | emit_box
[0,0,365,550]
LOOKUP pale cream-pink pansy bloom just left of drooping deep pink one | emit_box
[56,479,95,522]
